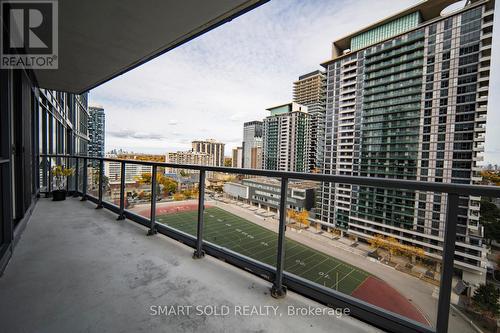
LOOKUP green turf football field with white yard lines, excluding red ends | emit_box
[156,207,370,294]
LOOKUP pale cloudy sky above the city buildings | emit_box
[90,0,500,164]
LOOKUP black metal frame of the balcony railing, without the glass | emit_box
[40,154,500,333]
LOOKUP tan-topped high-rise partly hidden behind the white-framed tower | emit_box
[293,70,326,172]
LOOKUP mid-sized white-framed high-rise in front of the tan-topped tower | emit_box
[262,102,309,172]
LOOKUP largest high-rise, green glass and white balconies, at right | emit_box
[316,0,494,283]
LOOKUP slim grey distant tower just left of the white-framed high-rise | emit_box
[242,121,262,169]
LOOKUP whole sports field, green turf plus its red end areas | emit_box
[155,204,428,324]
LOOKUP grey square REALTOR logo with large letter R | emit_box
[0,0,58,69]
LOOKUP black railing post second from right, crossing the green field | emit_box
[271,177,288,298]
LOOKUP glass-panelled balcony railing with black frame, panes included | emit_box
[39,154,500,333]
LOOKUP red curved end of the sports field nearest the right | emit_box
[352,276,430,325]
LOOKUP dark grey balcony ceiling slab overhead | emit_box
[34,0,268,93]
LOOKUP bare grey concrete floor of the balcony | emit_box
[0,198,377,333]
